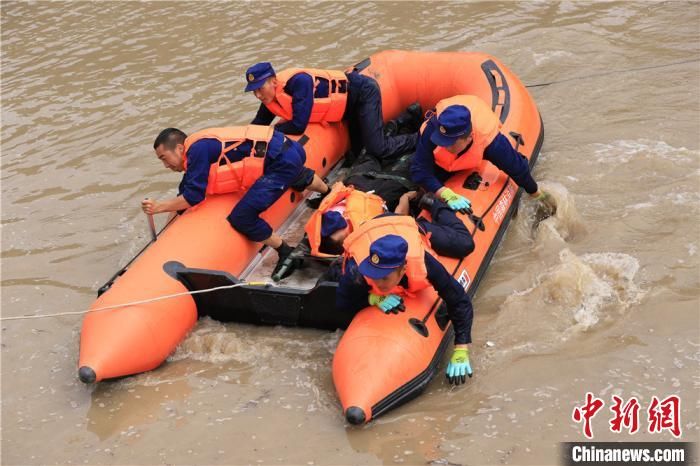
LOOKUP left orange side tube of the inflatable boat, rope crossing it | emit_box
[78,123,349,383]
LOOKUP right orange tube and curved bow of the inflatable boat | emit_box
[333,51,544,424]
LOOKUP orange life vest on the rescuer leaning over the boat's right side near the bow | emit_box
[420,95,501,172]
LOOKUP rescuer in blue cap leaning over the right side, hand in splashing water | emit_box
[411,95,556,215]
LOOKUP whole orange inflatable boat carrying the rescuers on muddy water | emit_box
[79,51,544,424]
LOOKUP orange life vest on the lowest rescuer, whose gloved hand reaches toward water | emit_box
[343,215,435,296]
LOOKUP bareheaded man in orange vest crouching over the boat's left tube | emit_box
[141,125,329,276]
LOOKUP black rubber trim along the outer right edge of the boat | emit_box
[372,116,544,418]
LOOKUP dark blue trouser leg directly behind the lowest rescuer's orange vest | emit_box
[417,199,474,259]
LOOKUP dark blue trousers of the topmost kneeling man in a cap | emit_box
[345,72,418,160]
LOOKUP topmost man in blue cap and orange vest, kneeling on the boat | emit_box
[245,62,422,164]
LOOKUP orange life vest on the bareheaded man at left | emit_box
[184,125,274,195]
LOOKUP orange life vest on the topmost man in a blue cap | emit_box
[265,68,348,123]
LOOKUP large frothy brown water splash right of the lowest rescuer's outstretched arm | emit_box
[484,248,644,356]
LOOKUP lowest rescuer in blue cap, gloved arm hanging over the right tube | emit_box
[336,226,474,385]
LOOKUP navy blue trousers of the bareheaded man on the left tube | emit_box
[227,142,314,242]
